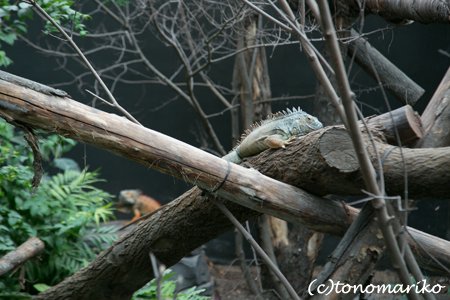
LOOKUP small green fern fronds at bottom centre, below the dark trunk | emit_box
[131,269,211,300]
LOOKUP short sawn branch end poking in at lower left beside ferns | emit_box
[0,237,45,276]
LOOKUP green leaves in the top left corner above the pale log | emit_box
[0,0,91,67]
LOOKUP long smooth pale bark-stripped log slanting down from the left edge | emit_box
[0,73,354,236]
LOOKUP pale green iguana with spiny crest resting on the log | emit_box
[222,107,323,164]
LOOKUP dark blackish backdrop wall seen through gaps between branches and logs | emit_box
[3,11,450,262]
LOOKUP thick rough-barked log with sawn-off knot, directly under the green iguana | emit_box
[244,126,450,200]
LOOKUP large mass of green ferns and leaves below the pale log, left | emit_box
[0,121,116,299]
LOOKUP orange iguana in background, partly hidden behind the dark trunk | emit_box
[117,190,161,222]
